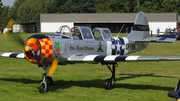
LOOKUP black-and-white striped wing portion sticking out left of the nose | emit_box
[0,52,25,59]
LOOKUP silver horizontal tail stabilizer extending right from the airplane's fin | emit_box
[134,37,176,43]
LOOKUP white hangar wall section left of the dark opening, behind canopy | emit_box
[41,22,74,32]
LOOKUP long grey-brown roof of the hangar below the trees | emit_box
[40,13,180,23]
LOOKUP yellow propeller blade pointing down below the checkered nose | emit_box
[47,58,58,77]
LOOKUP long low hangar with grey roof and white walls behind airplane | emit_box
[40,13,180,34]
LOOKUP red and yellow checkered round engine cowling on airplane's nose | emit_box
[24,38,53,65]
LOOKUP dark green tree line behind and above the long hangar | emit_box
[0,0,180,29]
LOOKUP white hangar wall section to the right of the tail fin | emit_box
[149,22,177,34]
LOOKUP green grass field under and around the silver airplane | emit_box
[0,33,180,101]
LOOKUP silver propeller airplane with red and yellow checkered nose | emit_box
[0,11,180,93]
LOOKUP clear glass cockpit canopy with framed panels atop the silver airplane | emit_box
[55,25,112,41]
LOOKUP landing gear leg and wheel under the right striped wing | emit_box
[104,63,118,90]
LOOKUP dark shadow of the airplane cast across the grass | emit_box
[0,74,175,91]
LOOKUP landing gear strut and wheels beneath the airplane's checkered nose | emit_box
[39,66,53,93]
